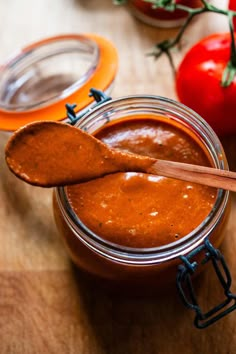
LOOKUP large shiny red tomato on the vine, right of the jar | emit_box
[176,33,236,135]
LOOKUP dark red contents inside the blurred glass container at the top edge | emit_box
[131,0,202,20]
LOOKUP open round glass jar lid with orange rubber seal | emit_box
[0,34,118,131]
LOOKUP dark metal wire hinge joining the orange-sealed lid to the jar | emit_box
[66,88,111,125]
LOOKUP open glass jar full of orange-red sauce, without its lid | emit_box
[54,96,229,326]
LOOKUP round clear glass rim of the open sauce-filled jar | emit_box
[56,95,229,264]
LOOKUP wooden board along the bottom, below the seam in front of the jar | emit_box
[0,268,236,354]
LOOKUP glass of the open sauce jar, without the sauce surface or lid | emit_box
[54,96,230,326]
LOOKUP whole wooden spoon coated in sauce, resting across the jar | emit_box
[5,121,236,191]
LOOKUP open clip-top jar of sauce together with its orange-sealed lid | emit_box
[0,34,234,328]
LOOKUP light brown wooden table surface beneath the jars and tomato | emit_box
[0,0,236,354]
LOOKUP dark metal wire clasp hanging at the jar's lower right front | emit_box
[176,239,236,329]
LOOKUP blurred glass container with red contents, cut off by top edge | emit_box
[128,0,202,28]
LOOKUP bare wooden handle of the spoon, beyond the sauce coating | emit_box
[146,160,236,192]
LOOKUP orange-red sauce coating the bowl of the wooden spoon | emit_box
[5,121,155,187]
